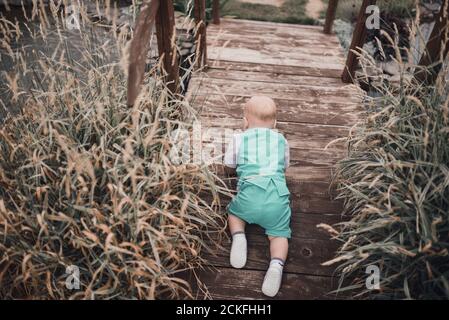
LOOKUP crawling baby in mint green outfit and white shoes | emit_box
[224,96,291,297]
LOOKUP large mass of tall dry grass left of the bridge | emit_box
[0,3,223,299]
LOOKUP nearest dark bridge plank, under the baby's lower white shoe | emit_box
[189,268,335,300]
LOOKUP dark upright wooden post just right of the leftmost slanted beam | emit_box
[156,0,179,93]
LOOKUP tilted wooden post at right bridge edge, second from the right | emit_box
[341,0,376,83]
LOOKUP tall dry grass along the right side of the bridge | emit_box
[325,10,449,299]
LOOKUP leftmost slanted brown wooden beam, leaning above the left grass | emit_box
[127,0,159,106]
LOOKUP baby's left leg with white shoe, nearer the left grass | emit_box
[228,214,247,269]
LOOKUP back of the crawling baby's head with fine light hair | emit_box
[243,96,276,129]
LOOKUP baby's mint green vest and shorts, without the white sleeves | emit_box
[228,128,291,238]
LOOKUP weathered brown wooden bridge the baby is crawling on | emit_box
[128,0,448,299]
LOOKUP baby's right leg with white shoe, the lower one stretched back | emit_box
[262,237,288,297]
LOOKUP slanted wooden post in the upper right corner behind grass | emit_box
[415,0,449,84]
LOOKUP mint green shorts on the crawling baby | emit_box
[228,181,291,238]
